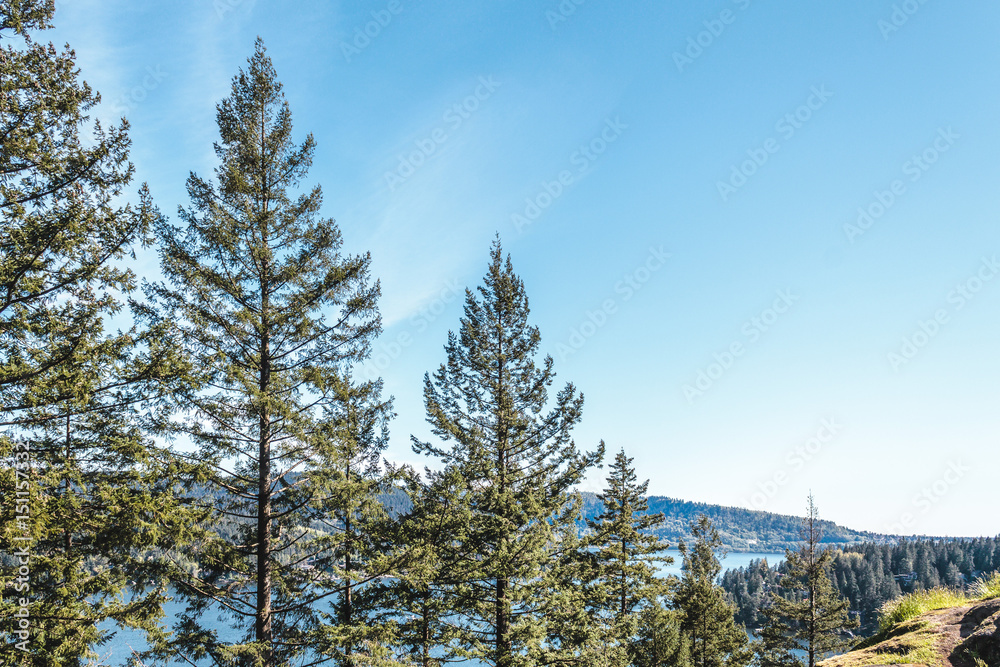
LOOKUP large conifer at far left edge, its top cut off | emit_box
[0,0,183,665]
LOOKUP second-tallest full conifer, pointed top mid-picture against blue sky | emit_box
[414,240,603,667]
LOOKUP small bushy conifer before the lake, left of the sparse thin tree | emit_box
[674,515,750,667]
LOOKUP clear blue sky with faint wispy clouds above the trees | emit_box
[49,0,1000,535]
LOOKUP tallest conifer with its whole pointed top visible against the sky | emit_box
[145,39,381,667]
